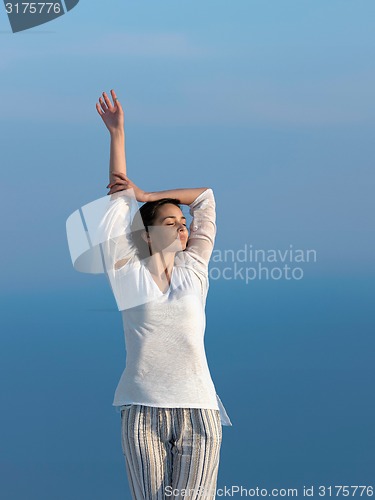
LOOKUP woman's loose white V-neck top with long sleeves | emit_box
[67,189,232,426]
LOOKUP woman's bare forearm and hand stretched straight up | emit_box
[96,90,126,184]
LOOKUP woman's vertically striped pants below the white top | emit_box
[121,404,222,500]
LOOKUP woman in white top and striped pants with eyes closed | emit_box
[67,90,232,499]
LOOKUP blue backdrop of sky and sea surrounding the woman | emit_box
[0,0,375,500]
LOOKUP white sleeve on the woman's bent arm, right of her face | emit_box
[185,188,216,270]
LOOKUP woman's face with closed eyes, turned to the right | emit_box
[148,203,189,253]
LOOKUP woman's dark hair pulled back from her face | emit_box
[131,198,181,260]
